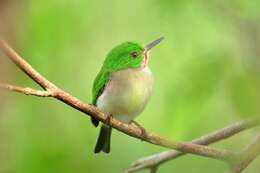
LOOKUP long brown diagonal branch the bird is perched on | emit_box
[0,39,235,162]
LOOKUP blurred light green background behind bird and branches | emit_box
[0,0,260,173]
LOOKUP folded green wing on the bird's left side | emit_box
[91,70,111,127]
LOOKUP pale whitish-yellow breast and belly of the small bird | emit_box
[97,67,153,122]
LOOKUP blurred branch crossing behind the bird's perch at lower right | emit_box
[128,120,259,173]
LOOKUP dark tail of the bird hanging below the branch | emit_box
[94,125,112,153]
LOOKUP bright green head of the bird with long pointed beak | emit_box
[103,37,163,71]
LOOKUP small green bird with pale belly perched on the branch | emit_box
[91,37,163,153]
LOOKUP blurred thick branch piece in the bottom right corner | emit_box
[226,134,260,173]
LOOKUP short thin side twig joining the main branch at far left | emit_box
[0,84,52,97]
